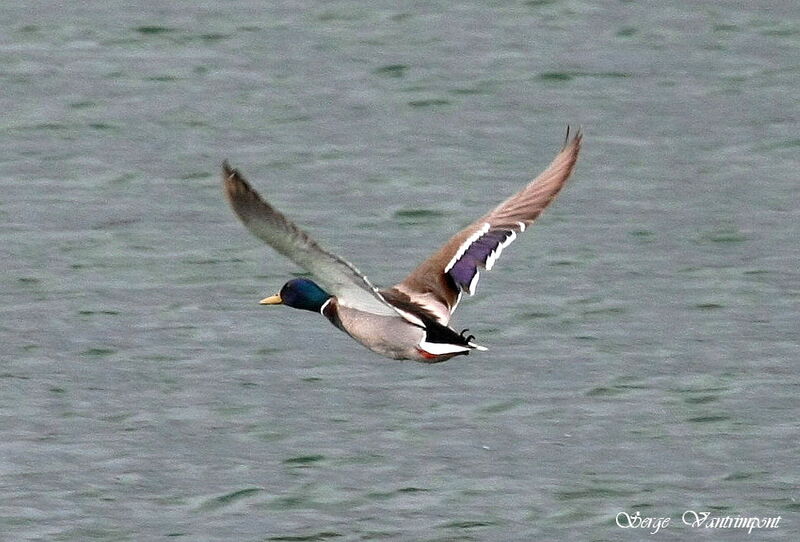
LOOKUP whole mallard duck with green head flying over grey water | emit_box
[222,130,581,363]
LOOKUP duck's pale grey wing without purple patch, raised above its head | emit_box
[222,166,398,316]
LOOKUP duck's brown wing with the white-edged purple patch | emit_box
[382,129,581,325]
